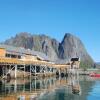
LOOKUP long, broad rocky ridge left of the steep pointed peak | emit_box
[4,33,59,61]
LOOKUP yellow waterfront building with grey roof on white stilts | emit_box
[0,45,80,79]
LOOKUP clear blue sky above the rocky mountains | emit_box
[0,0,100,62]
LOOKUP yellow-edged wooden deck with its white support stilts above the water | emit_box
[0,57,80,78]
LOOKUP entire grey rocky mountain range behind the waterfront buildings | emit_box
[4,32,94,67]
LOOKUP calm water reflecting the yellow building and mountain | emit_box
[0,76,100,100]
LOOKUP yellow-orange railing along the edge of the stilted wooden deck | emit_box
[0,57,79,69]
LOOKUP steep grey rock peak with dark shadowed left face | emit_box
[59,33,94,67]
